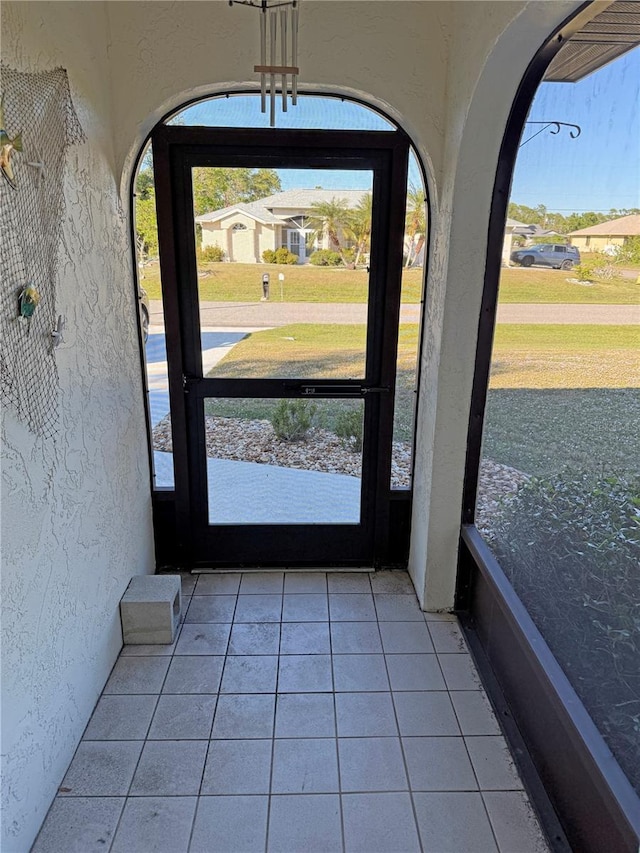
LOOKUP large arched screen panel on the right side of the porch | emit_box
[475,48,640,793]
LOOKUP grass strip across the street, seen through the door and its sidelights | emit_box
[141,263,423,303]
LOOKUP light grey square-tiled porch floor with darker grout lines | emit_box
[33,572,547,853]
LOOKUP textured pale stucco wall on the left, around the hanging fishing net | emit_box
[0,3,154,853]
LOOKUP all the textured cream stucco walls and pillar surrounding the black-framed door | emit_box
[2,0,600,853]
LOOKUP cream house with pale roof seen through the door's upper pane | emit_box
[196,189,367,264]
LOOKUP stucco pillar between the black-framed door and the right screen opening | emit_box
[409,0,597,610]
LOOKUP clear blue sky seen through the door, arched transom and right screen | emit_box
[175,48,640,213]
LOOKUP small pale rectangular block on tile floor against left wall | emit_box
[120,575,182,645]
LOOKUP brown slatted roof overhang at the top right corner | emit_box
[544,0,640,83]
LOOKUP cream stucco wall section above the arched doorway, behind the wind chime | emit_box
[108,0,455,195]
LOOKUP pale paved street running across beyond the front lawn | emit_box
[151,300,640,331]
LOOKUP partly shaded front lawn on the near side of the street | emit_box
[210,324,640,474]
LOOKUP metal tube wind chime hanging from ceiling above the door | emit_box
[229,0,300,127]
